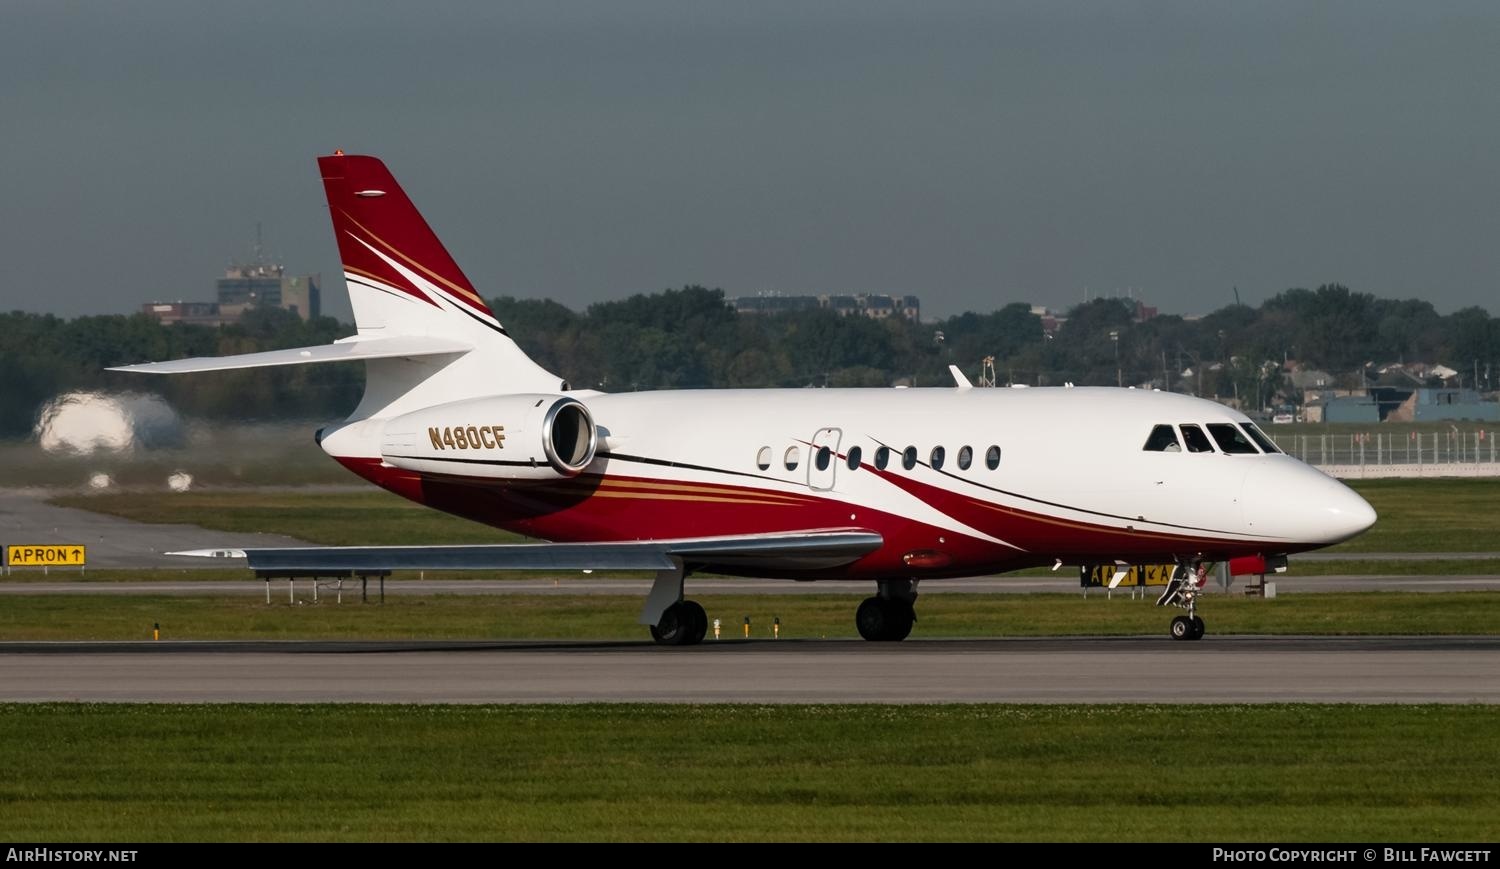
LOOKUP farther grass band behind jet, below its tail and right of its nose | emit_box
[53,479,1500,555]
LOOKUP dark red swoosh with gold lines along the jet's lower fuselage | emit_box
[339,458,1284,579]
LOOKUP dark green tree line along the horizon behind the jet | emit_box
[0,284,1500,437]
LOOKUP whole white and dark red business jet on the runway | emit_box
[119,152,1376,645]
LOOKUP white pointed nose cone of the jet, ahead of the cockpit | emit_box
[1244,459,1376,546]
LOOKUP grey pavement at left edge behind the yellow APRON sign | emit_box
[0,489,309,573]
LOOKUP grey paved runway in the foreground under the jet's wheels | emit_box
[0,636,1500,702]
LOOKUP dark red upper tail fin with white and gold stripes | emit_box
[318,153,492,320]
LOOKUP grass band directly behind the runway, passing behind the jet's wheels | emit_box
[0,584,1500,641]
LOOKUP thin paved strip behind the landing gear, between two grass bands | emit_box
[0,573,1500,594]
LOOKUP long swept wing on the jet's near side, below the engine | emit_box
[171,528,884,576]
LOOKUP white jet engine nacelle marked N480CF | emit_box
[380,395,599,480]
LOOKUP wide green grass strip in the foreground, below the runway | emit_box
[0,704,1500,842]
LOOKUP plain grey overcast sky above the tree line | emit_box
[0,0,1500,317]
